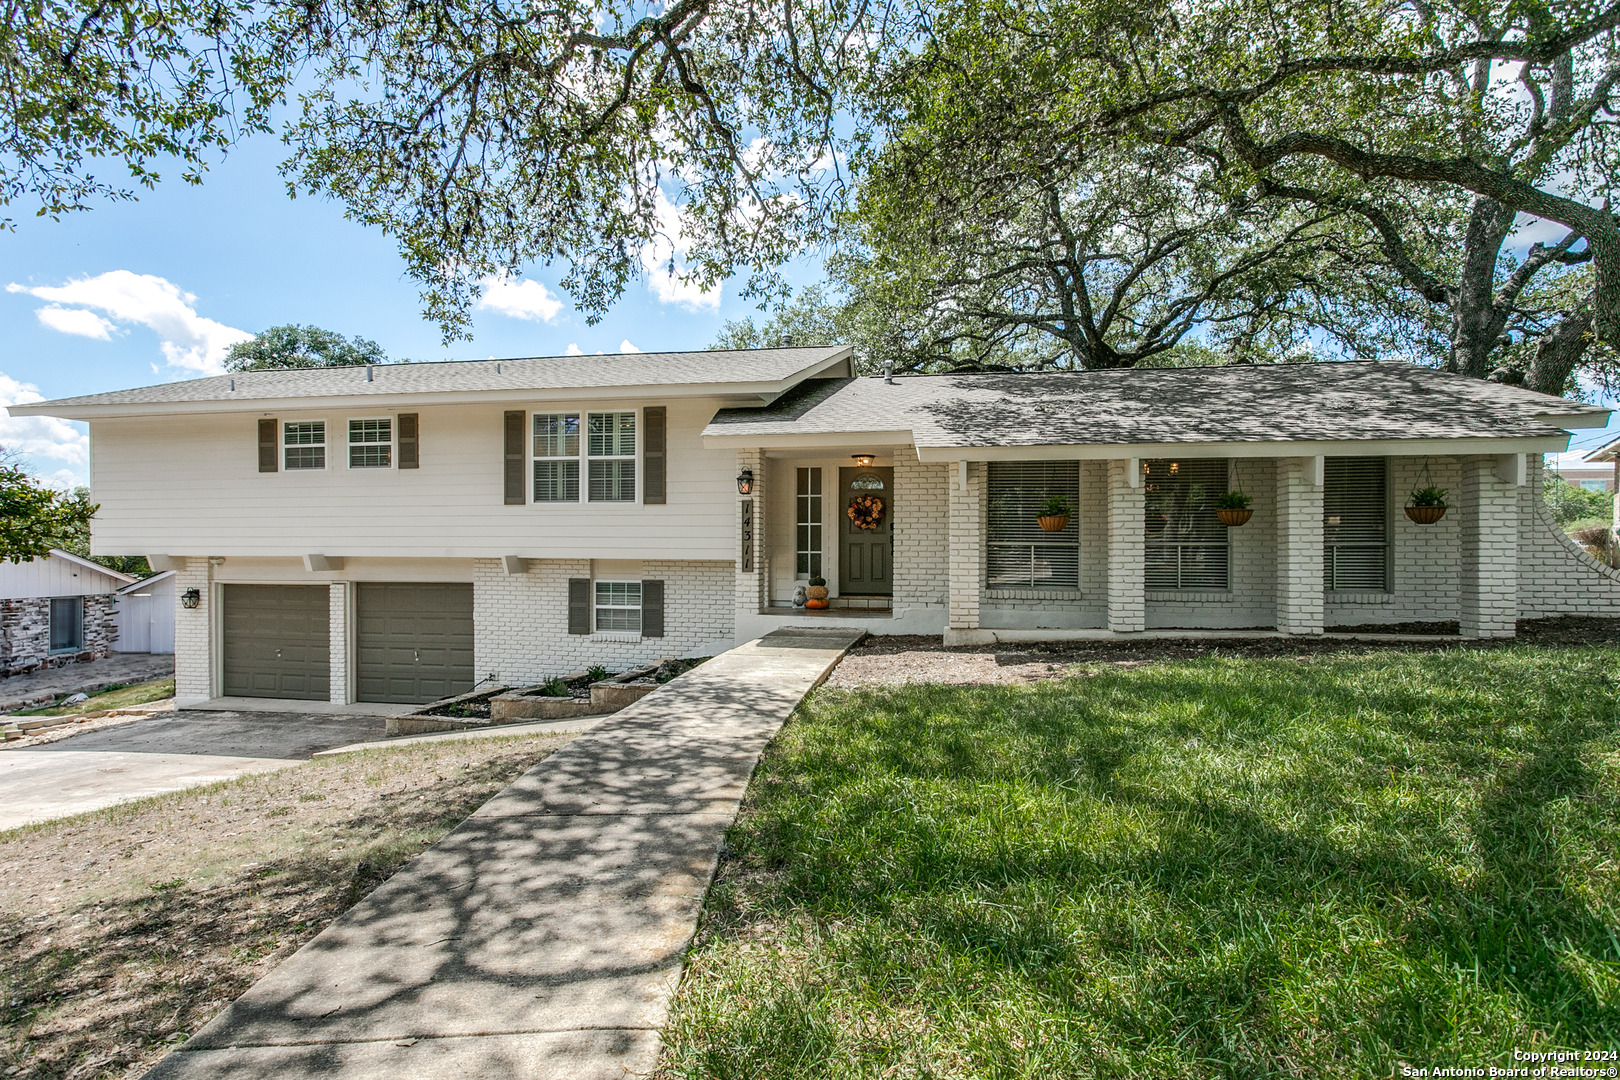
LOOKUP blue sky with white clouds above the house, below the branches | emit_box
[0,138,1620,486]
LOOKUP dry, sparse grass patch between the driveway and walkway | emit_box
[0,735,570,1080]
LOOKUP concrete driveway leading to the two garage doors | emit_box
[0,709,386,829]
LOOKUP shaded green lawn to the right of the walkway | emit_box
[661,646,1620,1080]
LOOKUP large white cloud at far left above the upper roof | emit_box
[5,270,253,376]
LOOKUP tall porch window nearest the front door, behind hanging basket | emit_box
[985,461,1081,589]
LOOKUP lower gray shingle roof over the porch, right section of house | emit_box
[703,361,1609,447]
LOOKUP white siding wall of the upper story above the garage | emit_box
[91,400,737,559]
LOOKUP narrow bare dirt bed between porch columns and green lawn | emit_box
[826,617,1620,688]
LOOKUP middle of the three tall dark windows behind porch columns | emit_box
[1142,458,1230,591]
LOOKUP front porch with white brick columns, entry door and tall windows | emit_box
[737,445,1539,644]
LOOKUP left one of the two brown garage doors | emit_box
[224,585,332,701]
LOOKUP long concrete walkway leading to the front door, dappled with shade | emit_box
[147,628,862,1080]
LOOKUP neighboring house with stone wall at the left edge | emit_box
[0,549,134,677]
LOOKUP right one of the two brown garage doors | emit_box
[355,581,473,704]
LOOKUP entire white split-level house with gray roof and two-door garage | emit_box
[11,348,1620,703]
